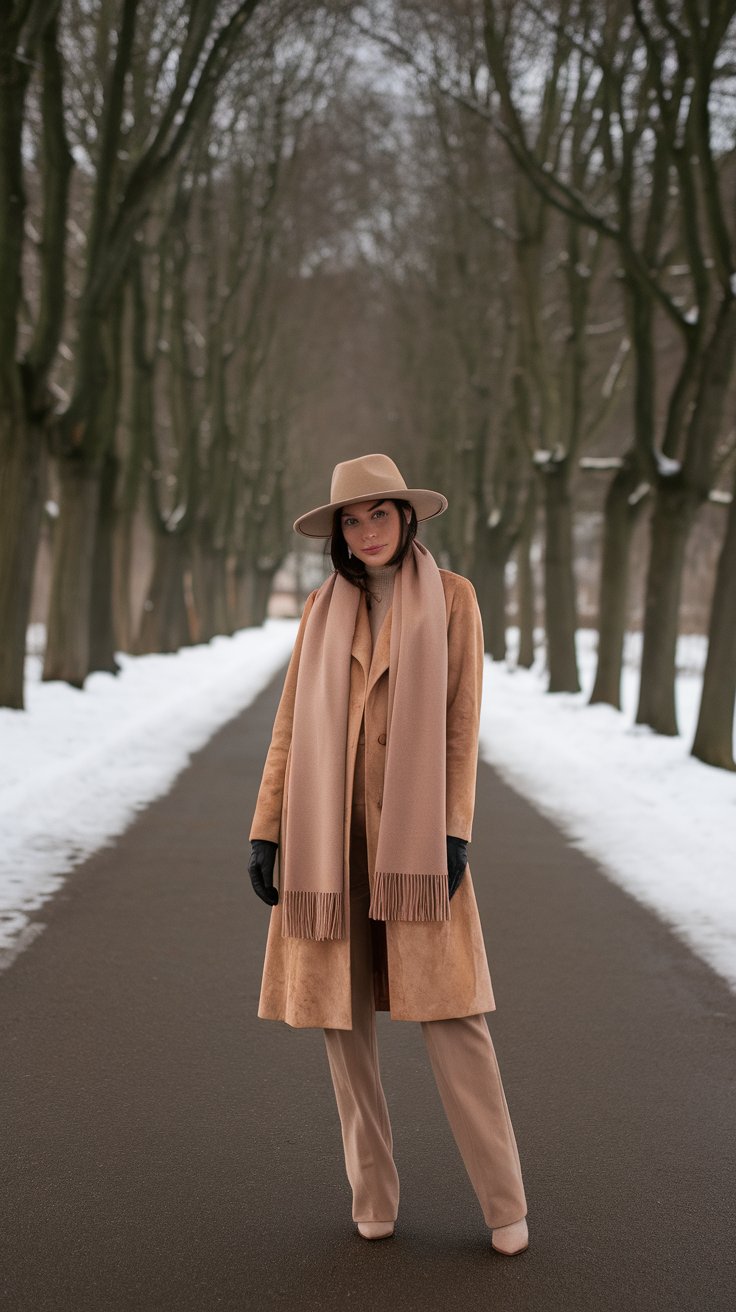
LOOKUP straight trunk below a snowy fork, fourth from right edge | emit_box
[543,458,580,693]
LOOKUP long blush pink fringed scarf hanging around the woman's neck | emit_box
[281,542,450,939]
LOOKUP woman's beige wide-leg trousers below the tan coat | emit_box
[324,766,526,1229]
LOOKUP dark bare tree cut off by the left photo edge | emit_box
[0,0,72,707]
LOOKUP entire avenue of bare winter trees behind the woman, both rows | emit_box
[0,0,736,769]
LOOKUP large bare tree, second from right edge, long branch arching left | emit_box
[472,0,736,733]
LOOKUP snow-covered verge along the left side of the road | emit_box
[0,619,299,968]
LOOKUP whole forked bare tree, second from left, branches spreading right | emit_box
[43,0,272,685]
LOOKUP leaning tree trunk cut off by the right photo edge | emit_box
[693,487,736,770]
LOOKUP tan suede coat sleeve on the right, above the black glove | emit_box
[447,575,483,838]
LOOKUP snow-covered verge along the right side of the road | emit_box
[480,631,736,989]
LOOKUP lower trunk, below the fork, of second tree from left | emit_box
[43,457,100,687]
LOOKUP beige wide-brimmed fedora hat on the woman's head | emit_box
[294,455,447,538]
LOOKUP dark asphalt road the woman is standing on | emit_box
[0,681,736,1312]
